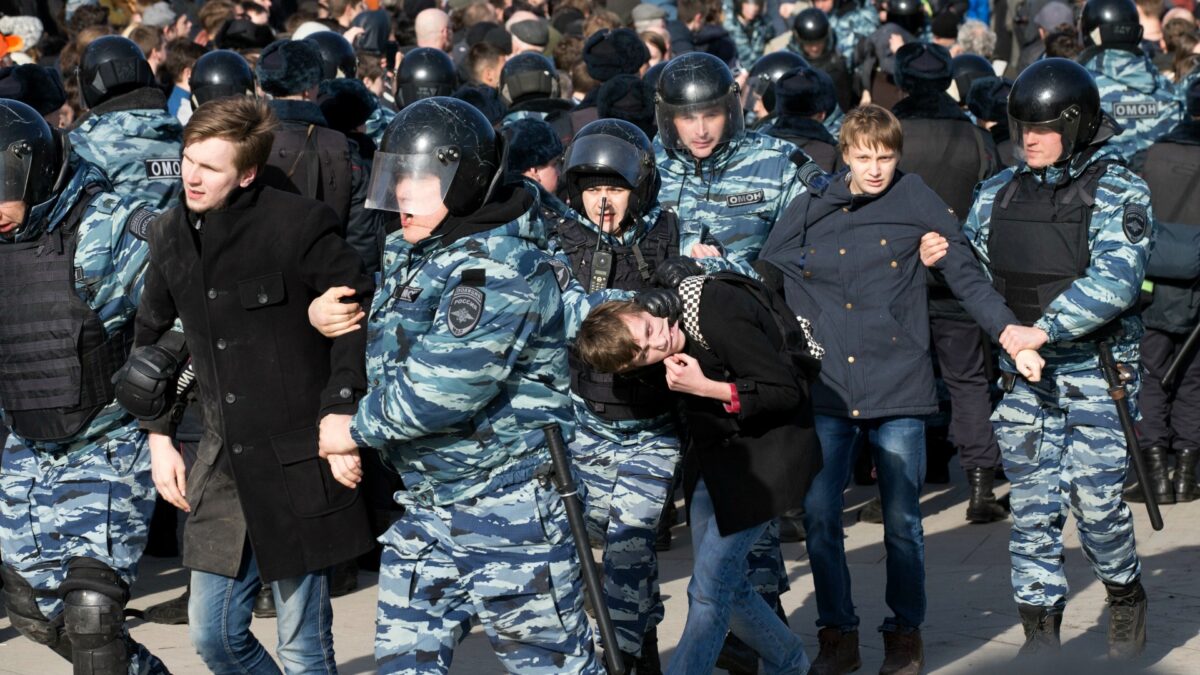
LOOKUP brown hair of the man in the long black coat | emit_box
[184,96,278,173]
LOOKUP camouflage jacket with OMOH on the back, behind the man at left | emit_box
[71,98,184,210]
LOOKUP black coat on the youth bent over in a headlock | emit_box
[683,280,821,536]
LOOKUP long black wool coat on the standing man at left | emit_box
[134,183,372,581]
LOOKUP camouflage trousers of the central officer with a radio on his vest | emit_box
[571,426,679,655]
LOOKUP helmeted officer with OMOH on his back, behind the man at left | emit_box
[71,35,184,209]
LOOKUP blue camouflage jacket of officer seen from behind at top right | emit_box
[1079,49,1183,159]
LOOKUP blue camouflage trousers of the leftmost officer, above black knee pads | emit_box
[0,424,167,674]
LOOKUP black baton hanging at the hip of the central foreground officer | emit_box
[541,424,625,675]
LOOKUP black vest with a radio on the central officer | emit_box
[558,211,679,422]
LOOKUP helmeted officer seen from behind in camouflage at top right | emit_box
[1076,0,1183,159]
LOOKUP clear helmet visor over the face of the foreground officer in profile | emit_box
[366,148,461,216]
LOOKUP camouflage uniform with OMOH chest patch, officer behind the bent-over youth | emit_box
[654,131,805,604]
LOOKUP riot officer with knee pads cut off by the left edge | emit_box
[0,98,167,675]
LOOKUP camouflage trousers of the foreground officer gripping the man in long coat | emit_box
[376,473,604,675]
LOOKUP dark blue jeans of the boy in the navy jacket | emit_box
[804,414,925,632]
